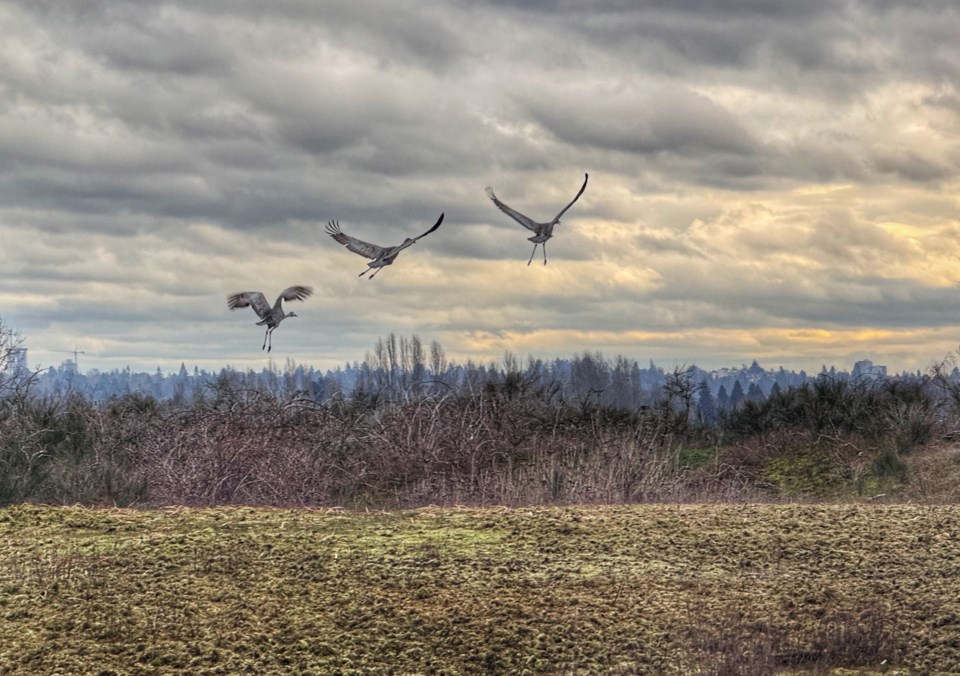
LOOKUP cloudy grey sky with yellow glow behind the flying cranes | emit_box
[0,0,960,370]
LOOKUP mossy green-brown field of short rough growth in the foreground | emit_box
[0,505,960,674]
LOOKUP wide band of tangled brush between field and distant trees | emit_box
[0,360,958,507]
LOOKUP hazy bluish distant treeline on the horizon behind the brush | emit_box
[36,334,820,410]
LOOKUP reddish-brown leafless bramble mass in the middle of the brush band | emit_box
[109,381,700,506]
